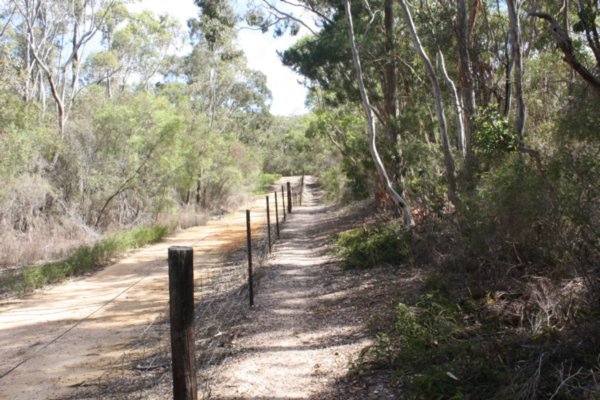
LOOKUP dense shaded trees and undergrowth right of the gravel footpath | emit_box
[283,1,600,399]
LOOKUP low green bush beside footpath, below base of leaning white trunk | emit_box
[335,223,411,269]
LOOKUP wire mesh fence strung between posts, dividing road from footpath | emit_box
[72,176,304,399]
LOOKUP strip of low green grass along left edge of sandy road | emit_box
[0,226,170,294]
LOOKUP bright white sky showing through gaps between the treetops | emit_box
[130,0,307,115]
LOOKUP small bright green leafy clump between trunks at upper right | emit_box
[475,105,519,157]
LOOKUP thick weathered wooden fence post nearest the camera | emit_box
[168,246,198,400]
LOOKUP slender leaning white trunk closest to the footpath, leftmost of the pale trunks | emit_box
[344,0,415,226]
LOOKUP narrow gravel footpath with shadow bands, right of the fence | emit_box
[211,177,370,400]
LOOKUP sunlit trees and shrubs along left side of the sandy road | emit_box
[0,0,308,293]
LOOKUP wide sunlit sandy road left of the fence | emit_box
[0,180,295,400]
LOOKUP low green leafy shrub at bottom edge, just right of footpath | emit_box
[361,291,482,399]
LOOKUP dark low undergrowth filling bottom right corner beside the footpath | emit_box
[353,278,600,400]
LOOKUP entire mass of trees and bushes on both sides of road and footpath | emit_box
[0,0,600,399]
